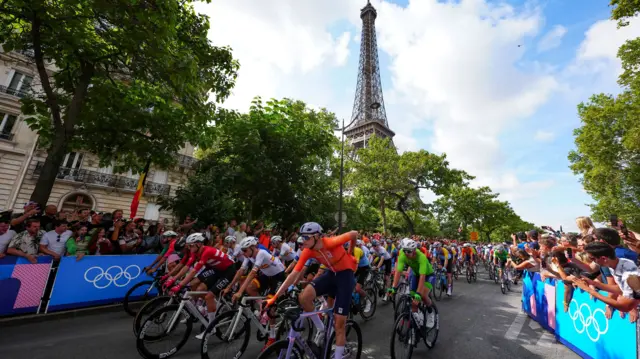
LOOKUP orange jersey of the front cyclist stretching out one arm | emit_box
[294,233,356,273]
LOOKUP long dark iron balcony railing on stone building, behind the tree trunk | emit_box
[33,162,171,196]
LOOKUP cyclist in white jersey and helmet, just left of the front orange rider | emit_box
[223,237,285,350]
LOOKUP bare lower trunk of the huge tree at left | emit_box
[31,130,68,208]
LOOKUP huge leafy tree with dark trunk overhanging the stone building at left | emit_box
[0,0,238,204]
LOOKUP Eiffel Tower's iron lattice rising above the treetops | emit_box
[344,1,395,149]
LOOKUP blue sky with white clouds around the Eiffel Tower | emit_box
[197,0,640,233]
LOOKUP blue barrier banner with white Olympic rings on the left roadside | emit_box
[47,254,156,312]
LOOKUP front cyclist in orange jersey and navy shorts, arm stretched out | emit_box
[268,222,358,358]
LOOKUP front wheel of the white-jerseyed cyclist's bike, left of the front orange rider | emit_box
[200,311,251,359]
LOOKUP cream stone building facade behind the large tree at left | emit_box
[0,47,197,223]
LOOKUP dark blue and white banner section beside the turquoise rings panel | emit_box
[522,271,556,333]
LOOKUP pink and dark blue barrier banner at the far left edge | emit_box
[0,256,53,316]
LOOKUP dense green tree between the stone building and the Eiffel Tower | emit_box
[165,98,338,228]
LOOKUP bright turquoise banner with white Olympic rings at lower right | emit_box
[556,283,638,359]
